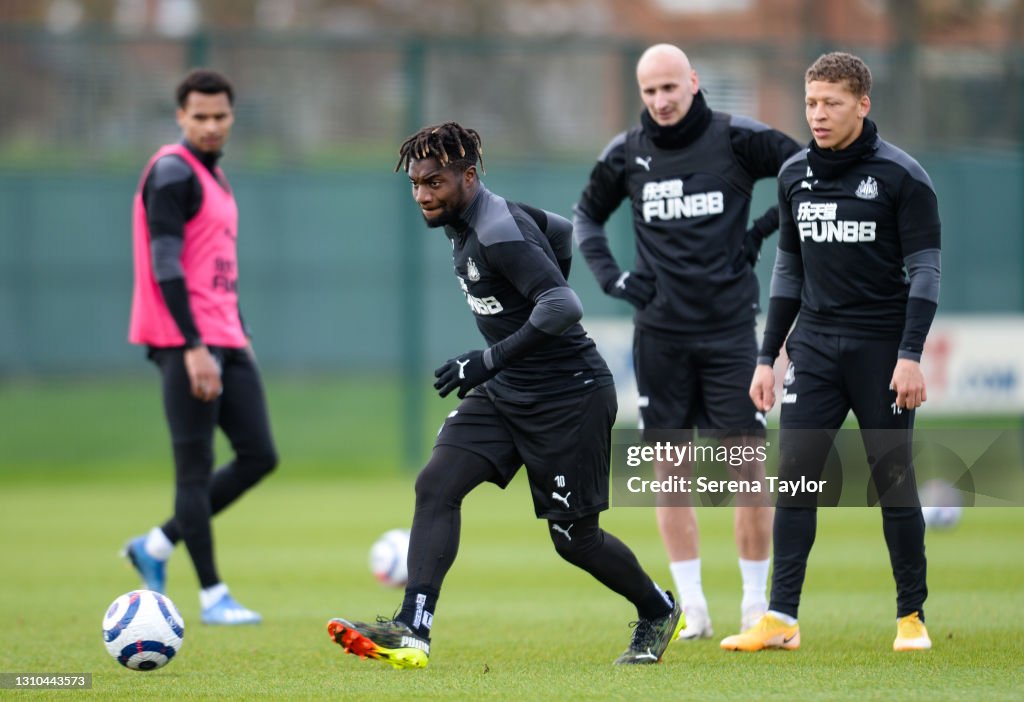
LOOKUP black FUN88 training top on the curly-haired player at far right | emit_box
[769,120,941,345]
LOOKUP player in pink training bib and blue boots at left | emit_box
[125,70,278,625]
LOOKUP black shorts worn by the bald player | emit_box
[633,326,765,440]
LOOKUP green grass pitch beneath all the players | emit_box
[0,379,1024,702]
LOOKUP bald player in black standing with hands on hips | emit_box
[573,44,800,640]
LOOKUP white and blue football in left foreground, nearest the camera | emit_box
[103,589,185,670]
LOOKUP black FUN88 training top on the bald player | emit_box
[575,92,800,335]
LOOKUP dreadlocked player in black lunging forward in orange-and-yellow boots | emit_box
[328,122,684,668]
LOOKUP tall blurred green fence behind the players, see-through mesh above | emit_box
[0,31,1024,376]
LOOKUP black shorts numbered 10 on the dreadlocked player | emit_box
[434,385,618,520]
